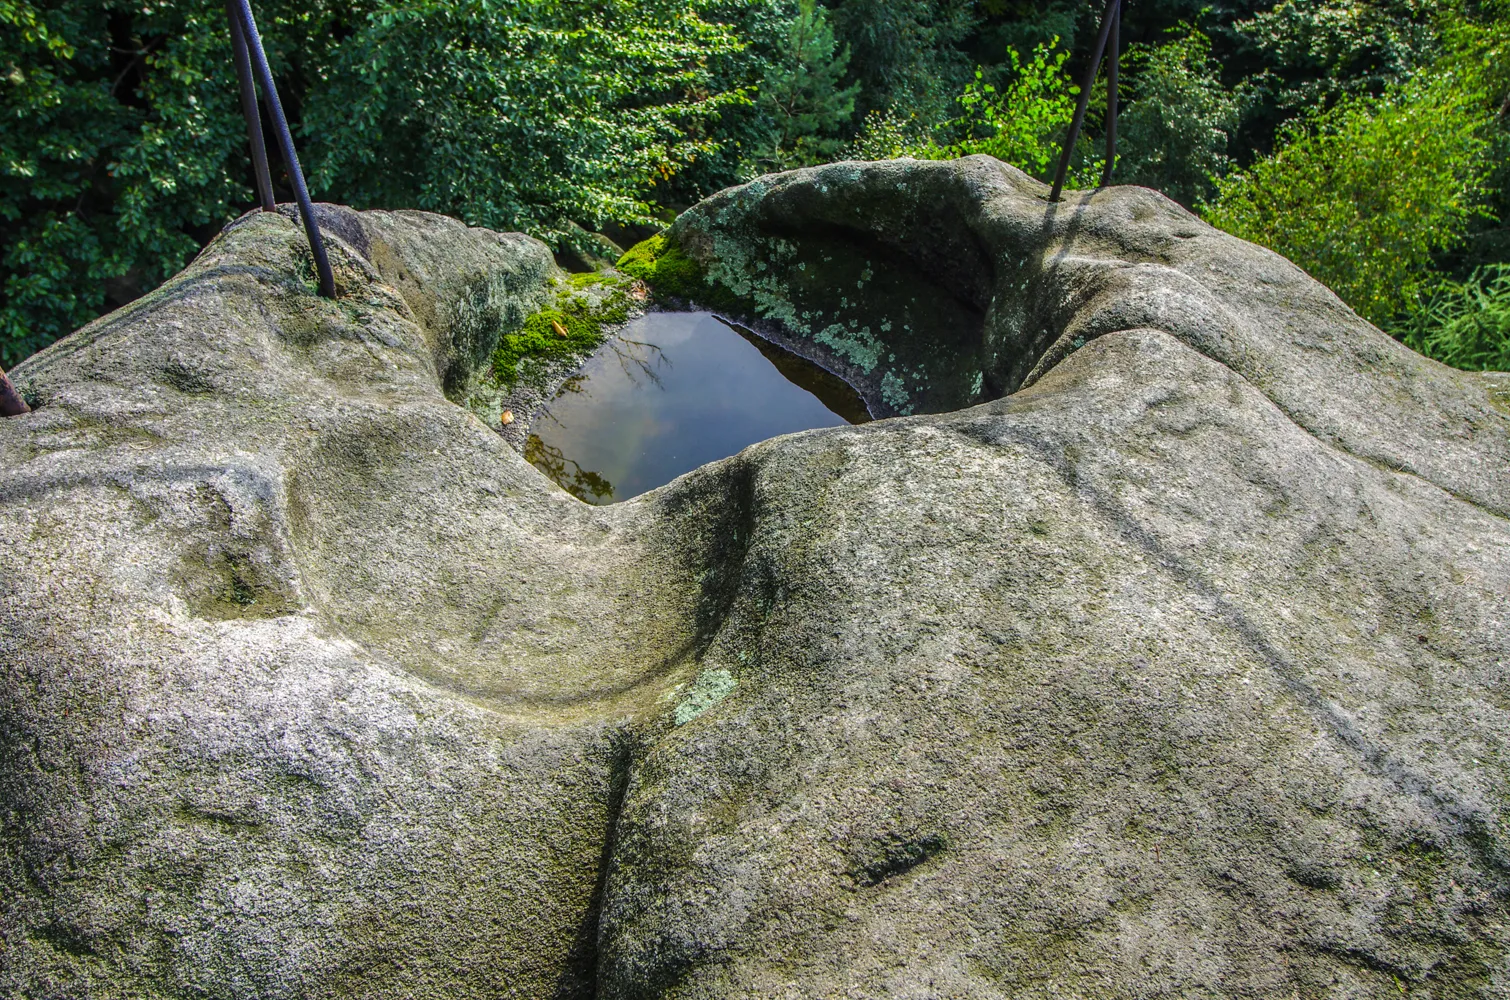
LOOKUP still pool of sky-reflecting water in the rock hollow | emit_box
[524,313,870,505]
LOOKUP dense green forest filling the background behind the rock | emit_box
[0,0,1510,369]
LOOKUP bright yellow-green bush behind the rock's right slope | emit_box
[1205,74,1487,325]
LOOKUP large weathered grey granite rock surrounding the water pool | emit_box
[0,157,1510,1000]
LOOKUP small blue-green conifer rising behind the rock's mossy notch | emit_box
[749,0,859,172]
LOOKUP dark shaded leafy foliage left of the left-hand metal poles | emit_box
[0,0,249,364]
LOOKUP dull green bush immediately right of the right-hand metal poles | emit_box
[1116,24,1243,205]
